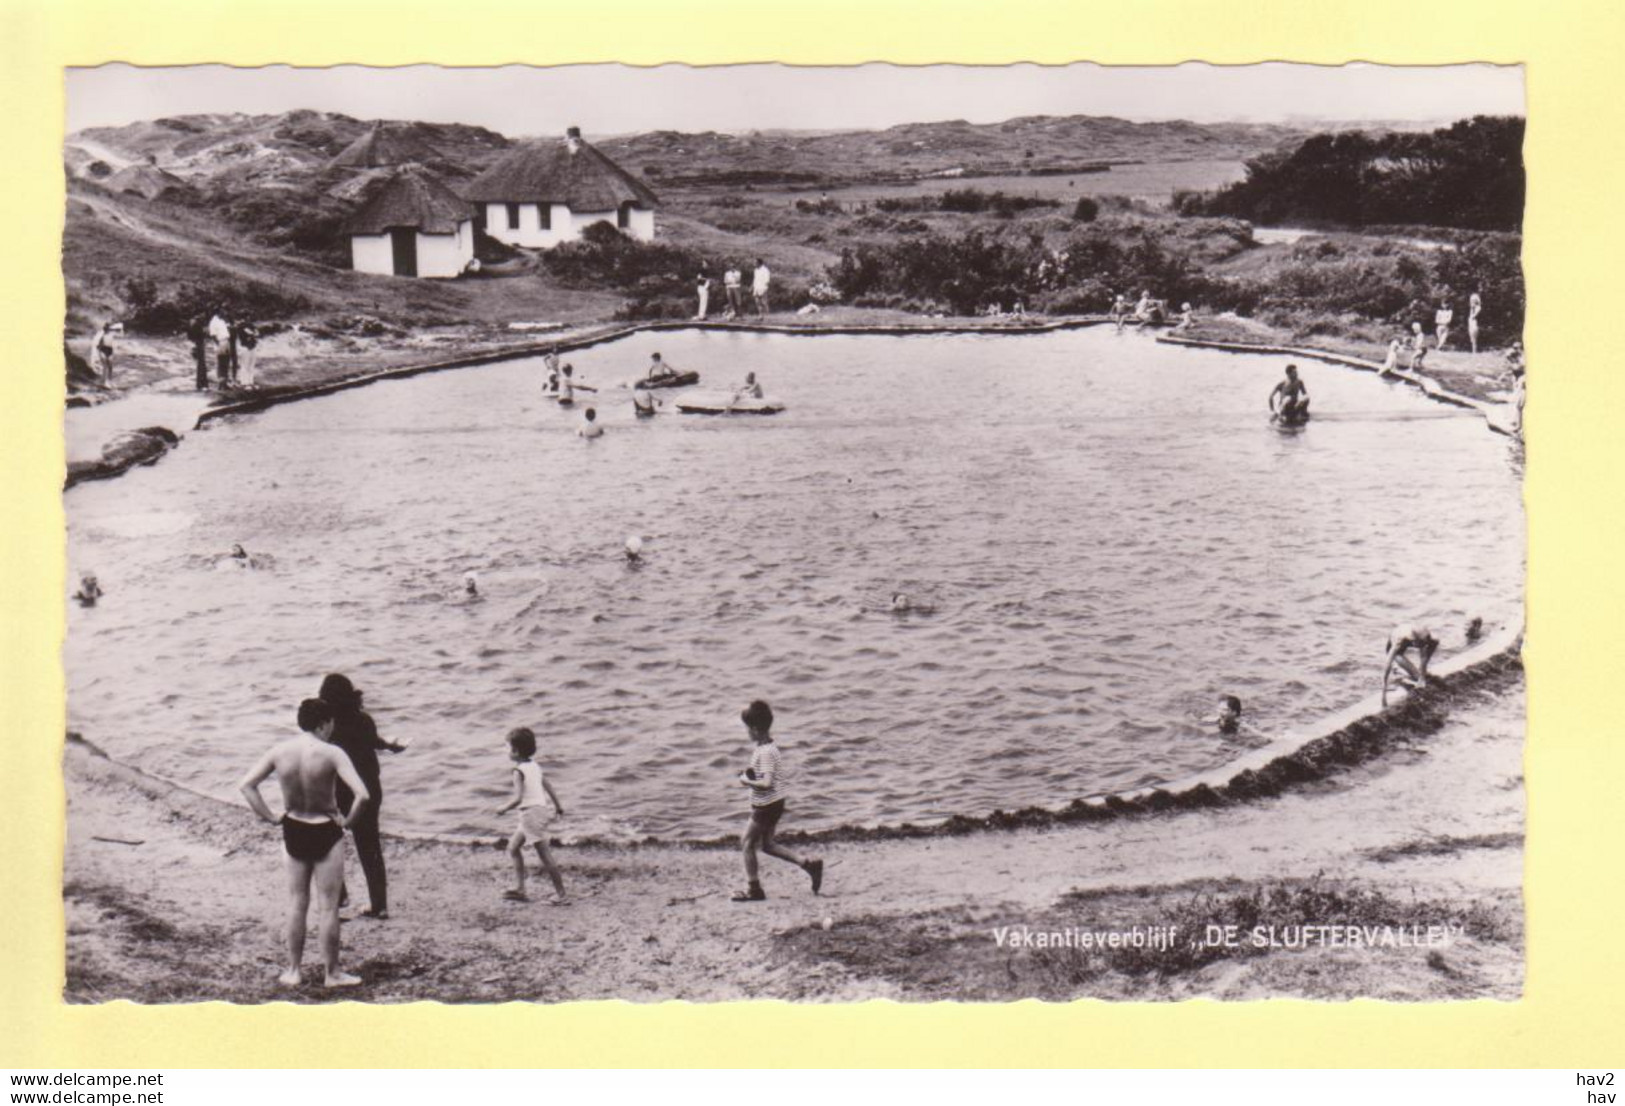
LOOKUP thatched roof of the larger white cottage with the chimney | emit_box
[462,128,660,211]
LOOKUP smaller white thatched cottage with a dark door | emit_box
[345,166,475,278]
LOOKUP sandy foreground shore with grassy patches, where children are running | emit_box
[65,652,1524,1002]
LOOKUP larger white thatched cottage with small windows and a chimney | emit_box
[463,127,660,247]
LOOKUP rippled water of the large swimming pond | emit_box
[65,328,1523,836]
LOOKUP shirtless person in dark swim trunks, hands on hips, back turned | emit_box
[241,698,372,987]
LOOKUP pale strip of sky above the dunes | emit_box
[67,62,1524,138]
